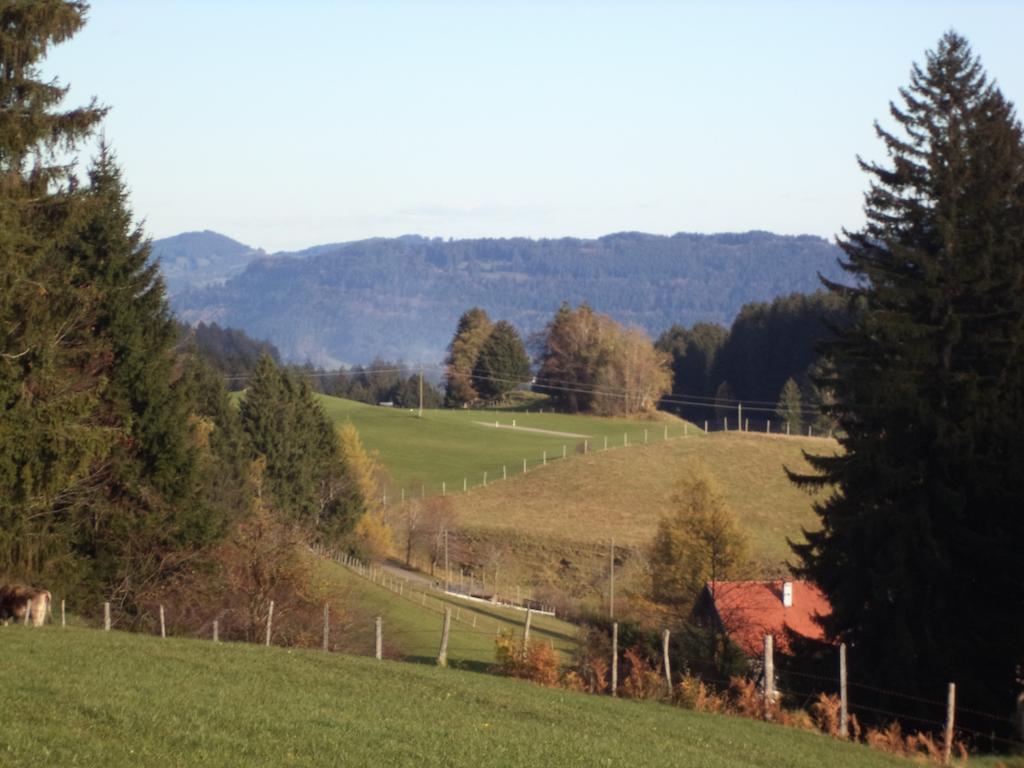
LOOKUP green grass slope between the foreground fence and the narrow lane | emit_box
[316,560,577,672]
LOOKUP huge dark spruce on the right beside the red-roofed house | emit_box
[795,32,1024,727]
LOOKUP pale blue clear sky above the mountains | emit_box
[42,0,1024,252]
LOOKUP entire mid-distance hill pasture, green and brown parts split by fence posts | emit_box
[322,397,837,584]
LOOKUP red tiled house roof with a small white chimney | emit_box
[705,581,831,656]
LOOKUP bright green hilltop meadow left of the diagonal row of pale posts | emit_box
[321,396,697,489]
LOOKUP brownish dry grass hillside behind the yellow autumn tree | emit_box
[452,432,837,572]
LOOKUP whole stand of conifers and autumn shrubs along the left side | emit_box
[0,0,383,632]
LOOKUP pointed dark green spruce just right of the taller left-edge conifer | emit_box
[61,144,210,608]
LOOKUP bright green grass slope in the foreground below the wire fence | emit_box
[0,627,911,768]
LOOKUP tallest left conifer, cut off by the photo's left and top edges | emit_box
[0,0,109,577]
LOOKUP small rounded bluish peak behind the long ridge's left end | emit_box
[153,229,266,295]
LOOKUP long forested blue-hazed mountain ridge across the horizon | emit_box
[162,231,843,365]
